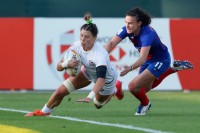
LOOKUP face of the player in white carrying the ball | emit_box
[80,29,96,51]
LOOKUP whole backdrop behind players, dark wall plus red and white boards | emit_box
[0,0,200,90]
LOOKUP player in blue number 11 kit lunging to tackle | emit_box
[105,8,193,115]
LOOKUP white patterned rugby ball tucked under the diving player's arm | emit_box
[64,49,81,77]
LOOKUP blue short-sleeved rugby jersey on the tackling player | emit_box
[116,26,169,61]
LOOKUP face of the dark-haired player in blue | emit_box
[125,16,142,35]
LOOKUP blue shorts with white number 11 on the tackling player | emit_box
[139,56,171,78]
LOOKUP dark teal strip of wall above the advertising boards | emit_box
[0,0,200,18]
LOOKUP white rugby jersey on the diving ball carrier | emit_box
[71,41,117,84]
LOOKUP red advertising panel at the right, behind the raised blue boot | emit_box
[170,19,200,90]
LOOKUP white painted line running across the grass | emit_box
[0,108,172,133]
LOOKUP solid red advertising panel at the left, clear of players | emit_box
[0,18,33,90]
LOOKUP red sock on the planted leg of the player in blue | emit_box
[131,88,149,106]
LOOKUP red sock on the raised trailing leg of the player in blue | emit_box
[152,67,177,89]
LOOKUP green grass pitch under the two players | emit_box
[0,91,200,133]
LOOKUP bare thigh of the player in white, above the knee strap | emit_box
[69,71,91,89]
